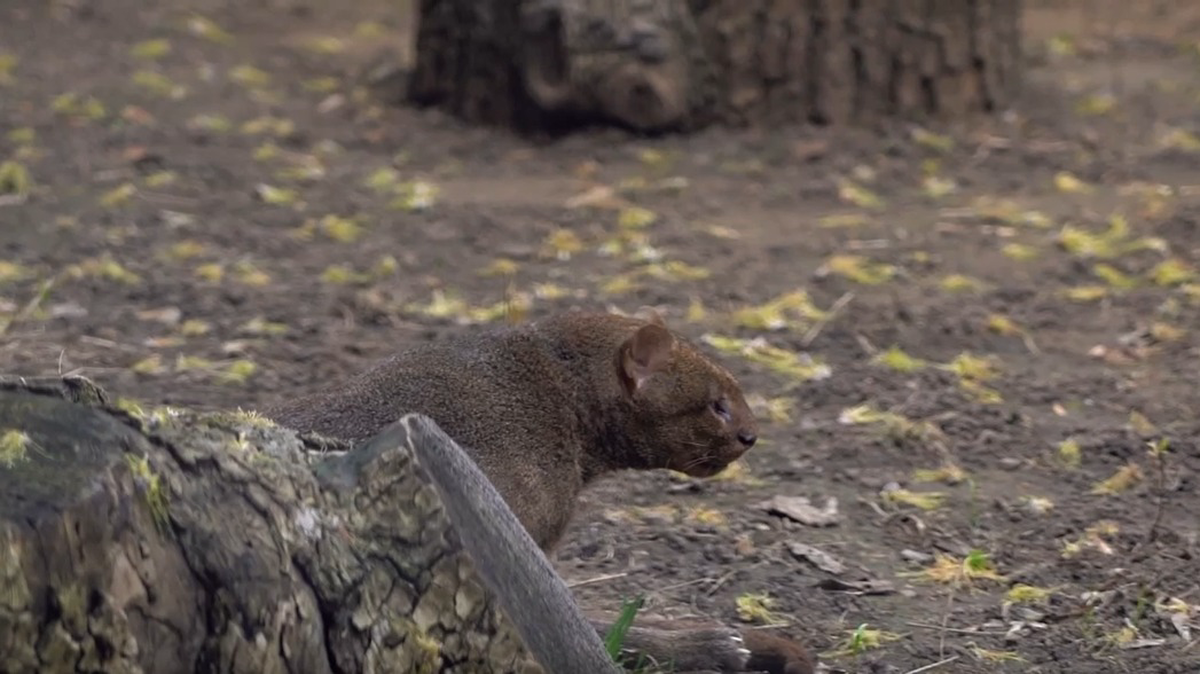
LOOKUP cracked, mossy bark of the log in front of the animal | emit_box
[0,378,539,674]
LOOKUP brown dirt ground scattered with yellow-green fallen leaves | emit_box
[0,0,1200,674]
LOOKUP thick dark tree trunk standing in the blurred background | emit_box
[408,0,1021,132]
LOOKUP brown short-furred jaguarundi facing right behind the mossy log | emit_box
[264,312,808,673]
